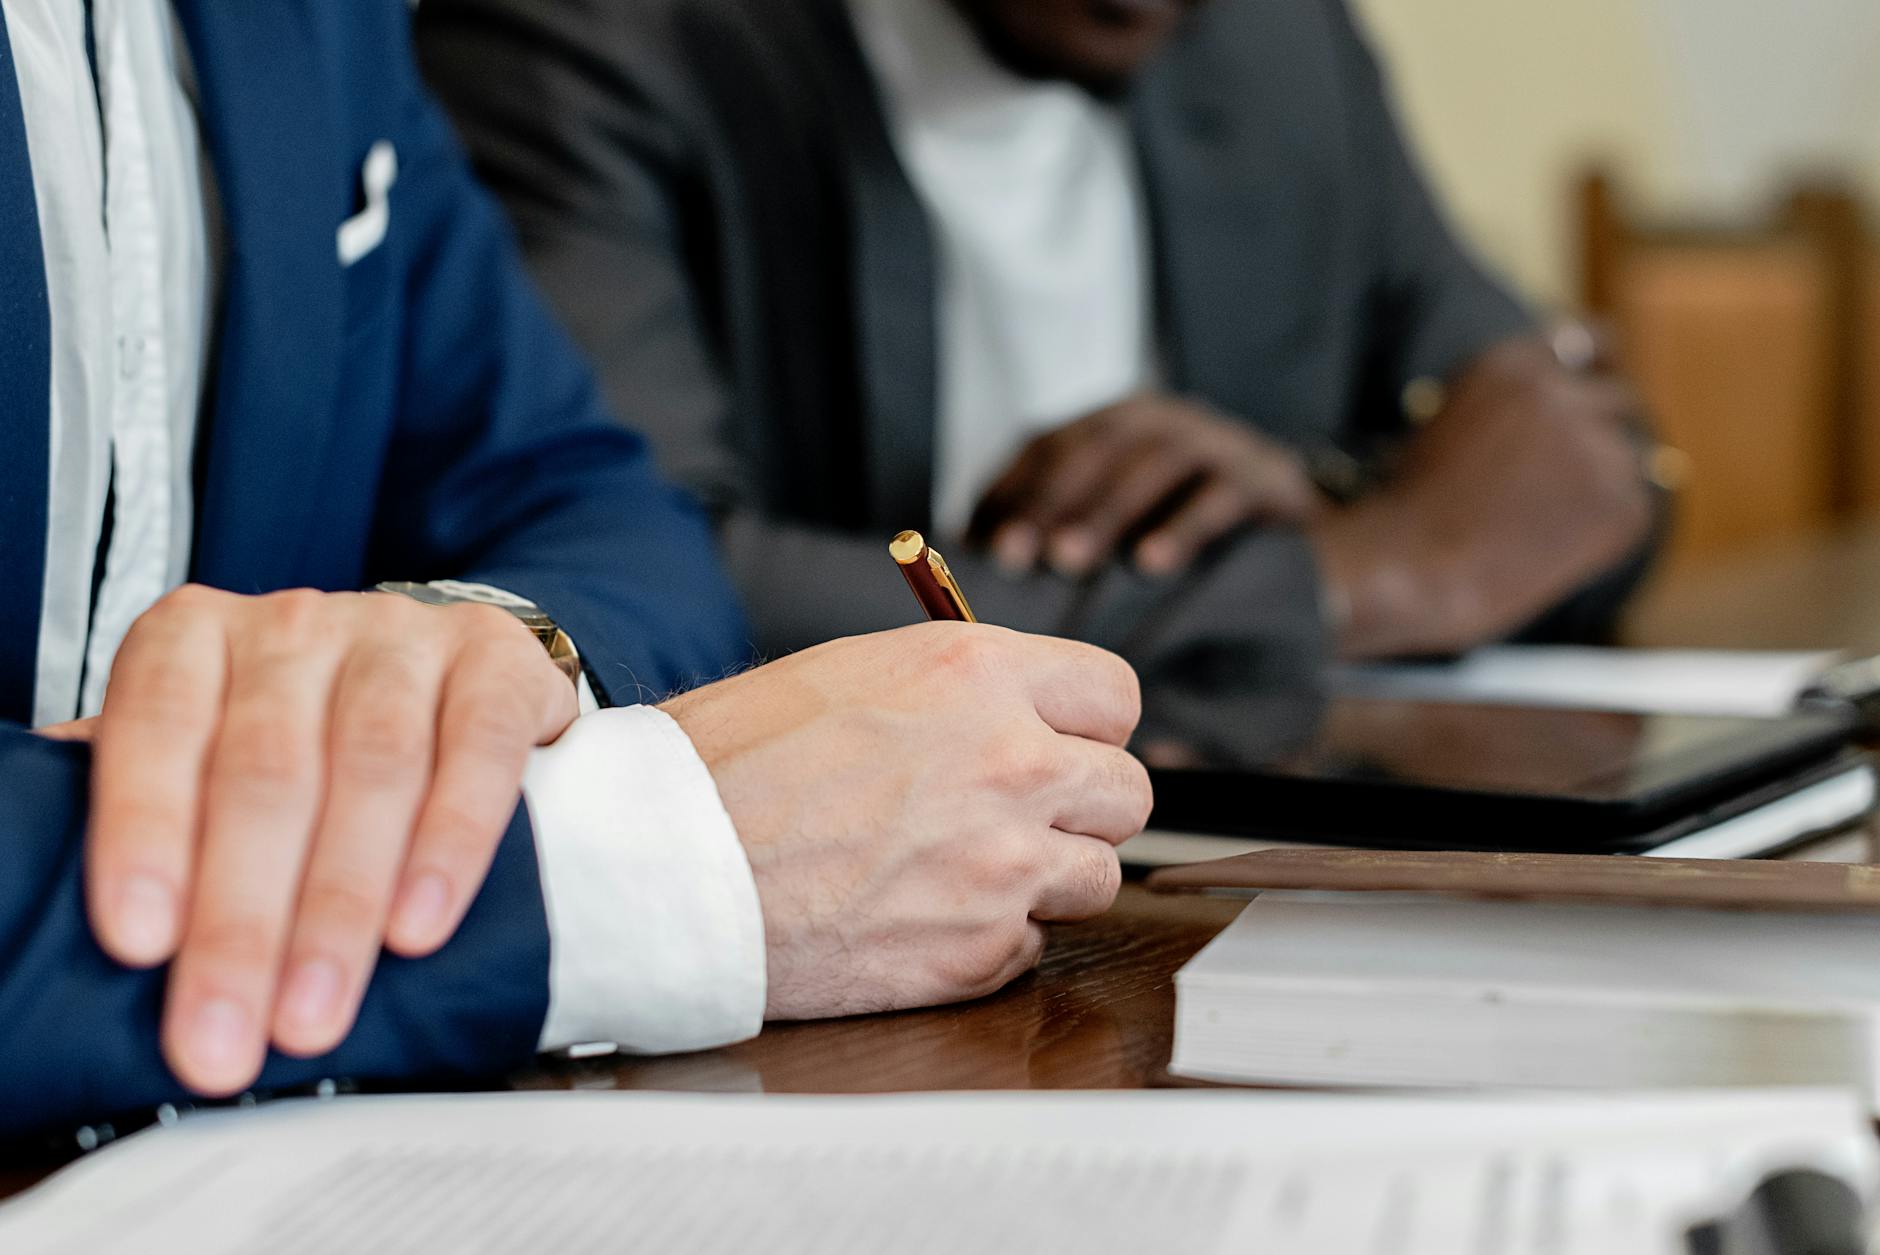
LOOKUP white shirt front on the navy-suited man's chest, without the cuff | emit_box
[6,0,211,723]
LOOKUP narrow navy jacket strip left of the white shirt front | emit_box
[0,13,53,723]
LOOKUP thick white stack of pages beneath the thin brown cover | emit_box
[1171,892,1880,1090]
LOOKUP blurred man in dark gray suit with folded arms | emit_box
[417,0,1654,680]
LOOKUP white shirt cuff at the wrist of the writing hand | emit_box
[523,703,767,1054]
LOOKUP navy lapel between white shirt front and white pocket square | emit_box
[175,0,353,592]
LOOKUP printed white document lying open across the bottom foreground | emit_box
[0,1090,1872,1255]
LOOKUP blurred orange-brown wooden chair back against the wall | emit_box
[1579,173,1880,564]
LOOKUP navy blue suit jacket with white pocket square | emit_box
[0,0,746,1133]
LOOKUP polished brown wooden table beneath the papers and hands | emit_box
[11,526,1880,1197]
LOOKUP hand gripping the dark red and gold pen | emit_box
[664,624,1151,1020]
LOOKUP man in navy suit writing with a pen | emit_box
[0,0,1149,1131]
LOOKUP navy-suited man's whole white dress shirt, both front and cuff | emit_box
[0,0,767,1050]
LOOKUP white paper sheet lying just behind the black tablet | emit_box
[1335,644,1841,718]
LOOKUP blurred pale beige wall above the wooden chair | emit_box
[1354,0,1880,302]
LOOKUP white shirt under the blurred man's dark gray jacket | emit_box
[850,0,1156,535]
